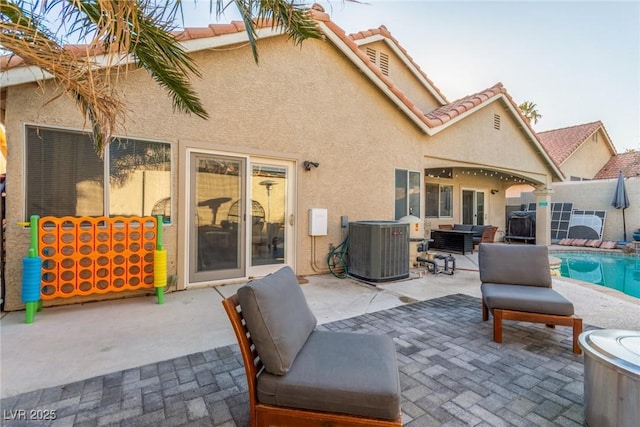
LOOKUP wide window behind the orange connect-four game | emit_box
[25,126,171,222]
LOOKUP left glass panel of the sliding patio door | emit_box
[190,154,245,281]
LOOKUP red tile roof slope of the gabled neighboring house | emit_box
[538,120,608,164]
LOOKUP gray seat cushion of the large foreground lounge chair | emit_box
[257,331,400,419]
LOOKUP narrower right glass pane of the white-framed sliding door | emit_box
[251,163,288,266]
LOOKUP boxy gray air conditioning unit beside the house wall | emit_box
[347,221,409,282]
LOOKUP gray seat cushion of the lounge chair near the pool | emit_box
[480,283,574,316]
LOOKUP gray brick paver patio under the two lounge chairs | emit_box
[1,295,584,427]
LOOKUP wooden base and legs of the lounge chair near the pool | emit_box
[482,299,582,354]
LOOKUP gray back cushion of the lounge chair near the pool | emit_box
[478,243,551,288]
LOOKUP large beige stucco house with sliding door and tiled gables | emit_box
[0,6,564,310]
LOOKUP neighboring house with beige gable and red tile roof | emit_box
[538,121,616,181]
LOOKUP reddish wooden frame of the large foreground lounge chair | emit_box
[222,294,402,427]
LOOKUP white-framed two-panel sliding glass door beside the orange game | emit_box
[188,153,295,283]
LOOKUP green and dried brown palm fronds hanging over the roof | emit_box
[0,0,330,155]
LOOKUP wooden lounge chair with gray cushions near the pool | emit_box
[478,243,582,354]
